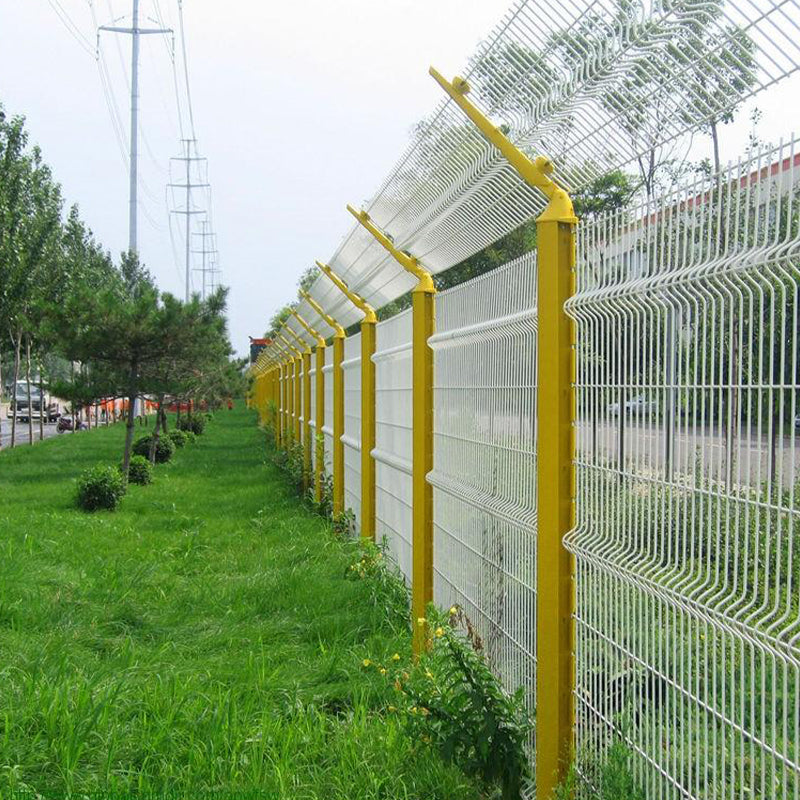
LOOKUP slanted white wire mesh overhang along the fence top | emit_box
[296,0,800,334]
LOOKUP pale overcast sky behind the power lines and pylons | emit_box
[0,0,800,353]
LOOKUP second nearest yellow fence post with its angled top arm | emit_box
[347,206,436,656]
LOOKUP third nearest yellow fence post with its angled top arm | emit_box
[317,261,378,542]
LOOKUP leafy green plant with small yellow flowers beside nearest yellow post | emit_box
[389,606,531,800]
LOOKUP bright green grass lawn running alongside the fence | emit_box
[0,408,479,800]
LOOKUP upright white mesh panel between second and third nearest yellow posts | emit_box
[373,309,412,580]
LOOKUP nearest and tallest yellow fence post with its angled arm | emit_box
[430,67,578,800]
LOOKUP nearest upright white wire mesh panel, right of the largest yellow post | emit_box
[567,141,800,800]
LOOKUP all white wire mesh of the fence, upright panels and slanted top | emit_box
[248,0,800,800]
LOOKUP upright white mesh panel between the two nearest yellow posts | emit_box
[429,254,536,748]
